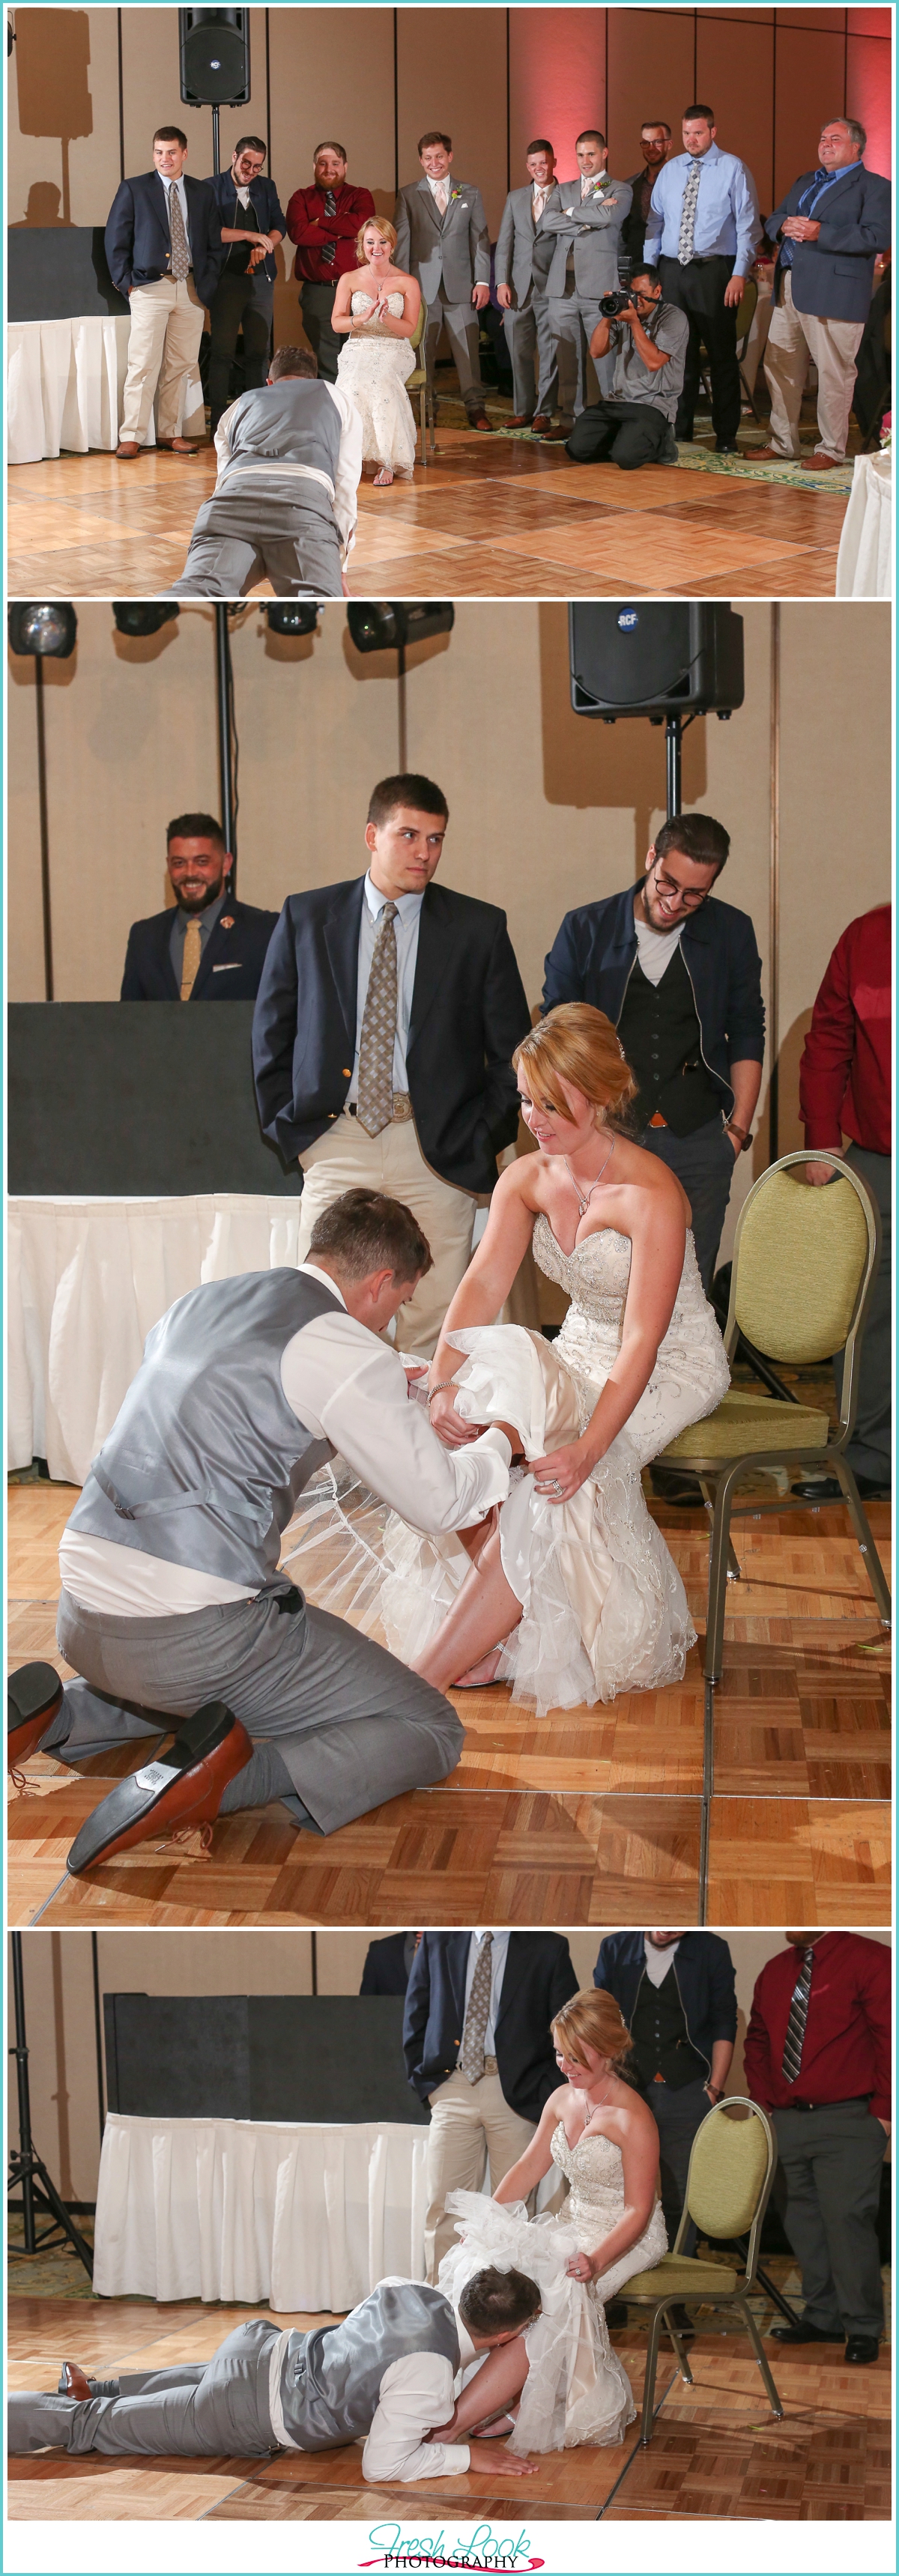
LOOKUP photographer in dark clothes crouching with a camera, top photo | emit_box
[564,268,688,474]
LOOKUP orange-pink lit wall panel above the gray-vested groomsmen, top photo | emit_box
[510,7,605,186]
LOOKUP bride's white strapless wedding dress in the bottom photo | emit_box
[438,2120,668,2452]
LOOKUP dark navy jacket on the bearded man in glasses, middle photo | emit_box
[541,886,765,1110]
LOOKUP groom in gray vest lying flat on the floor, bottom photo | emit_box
[10,2267,541,2486]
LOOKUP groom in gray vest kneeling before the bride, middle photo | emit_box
[10,1190,510,1873]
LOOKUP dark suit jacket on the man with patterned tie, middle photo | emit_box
[252,876,530,1190]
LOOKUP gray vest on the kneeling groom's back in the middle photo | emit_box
[70,1270,342,1595]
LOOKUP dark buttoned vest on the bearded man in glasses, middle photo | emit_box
[618,948,724,1136]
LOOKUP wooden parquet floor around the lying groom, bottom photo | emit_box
[7,2298,892,2522]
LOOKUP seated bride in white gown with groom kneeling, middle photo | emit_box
[381,1002,729,1713]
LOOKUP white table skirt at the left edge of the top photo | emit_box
[5,315,206,466]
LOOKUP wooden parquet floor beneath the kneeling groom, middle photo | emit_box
[7,1484,892,1927]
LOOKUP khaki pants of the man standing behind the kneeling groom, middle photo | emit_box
[296,1110,476,1360]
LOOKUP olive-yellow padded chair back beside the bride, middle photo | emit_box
[724,1149,881,1437]
